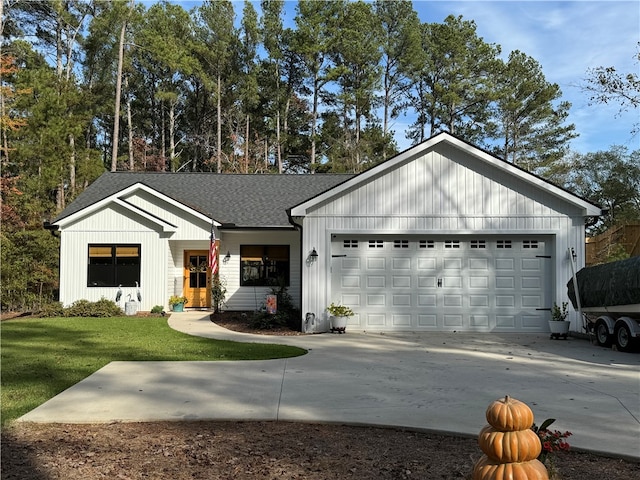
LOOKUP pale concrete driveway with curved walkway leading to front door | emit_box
[20,312,640,460]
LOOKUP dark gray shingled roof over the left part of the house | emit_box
[52,172,353,227]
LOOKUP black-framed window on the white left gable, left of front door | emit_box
[87,243,142,288]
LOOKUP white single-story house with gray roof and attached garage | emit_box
[48,133,601,332]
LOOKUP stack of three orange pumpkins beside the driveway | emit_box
[473,395,549,480]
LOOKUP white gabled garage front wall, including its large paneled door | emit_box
[292,144,596,332]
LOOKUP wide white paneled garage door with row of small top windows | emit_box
[331,235,551,332]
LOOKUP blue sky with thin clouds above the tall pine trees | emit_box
[168,0,640,153]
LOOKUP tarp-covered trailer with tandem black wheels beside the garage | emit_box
[567,257,640,352]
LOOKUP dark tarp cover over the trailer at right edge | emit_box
[567,257,640,308]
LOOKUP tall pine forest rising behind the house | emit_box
[0,0,640,311]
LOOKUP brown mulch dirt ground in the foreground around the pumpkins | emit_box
[2,422,640,480]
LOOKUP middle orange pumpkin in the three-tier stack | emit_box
[478,425,542,463]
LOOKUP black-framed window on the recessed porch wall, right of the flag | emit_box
[240,244,291,287]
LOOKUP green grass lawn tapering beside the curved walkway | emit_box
[0,317,306,426]
